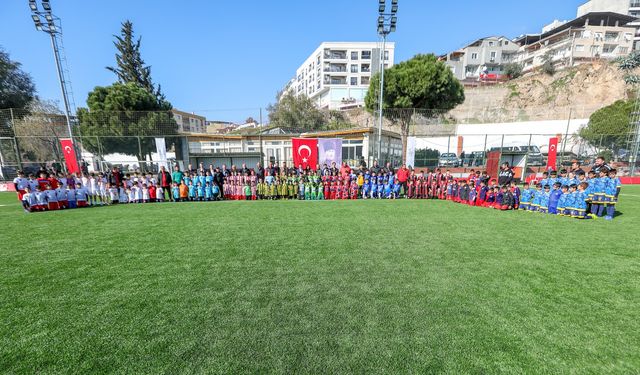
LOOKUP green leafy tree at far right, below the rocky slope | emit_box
[579,100,635,158]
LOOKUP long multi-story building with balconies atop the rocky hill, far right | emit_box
[506,12,636,72]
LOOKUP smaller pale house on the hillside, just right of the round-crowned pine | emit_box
[440,36,519,81]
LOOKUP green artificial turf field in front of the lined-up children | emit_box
[0,187,640,374]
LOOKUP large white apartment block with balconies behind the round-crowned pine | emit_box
[283,42,395,109]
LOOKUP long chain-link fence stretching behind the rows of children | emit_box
[0,108,640,180]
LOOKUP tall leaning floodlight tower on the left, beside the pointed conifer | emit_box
[29,0,73,146]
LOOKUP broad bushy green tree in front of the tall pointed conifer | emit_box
[78,82,178,170]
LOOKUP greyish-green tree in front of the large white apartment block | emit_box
[267,93,327,130]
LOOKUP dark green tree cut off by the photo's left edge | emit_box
[0,48,36,109]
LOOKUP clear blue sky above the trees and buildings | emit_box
[0,0,584,121]
